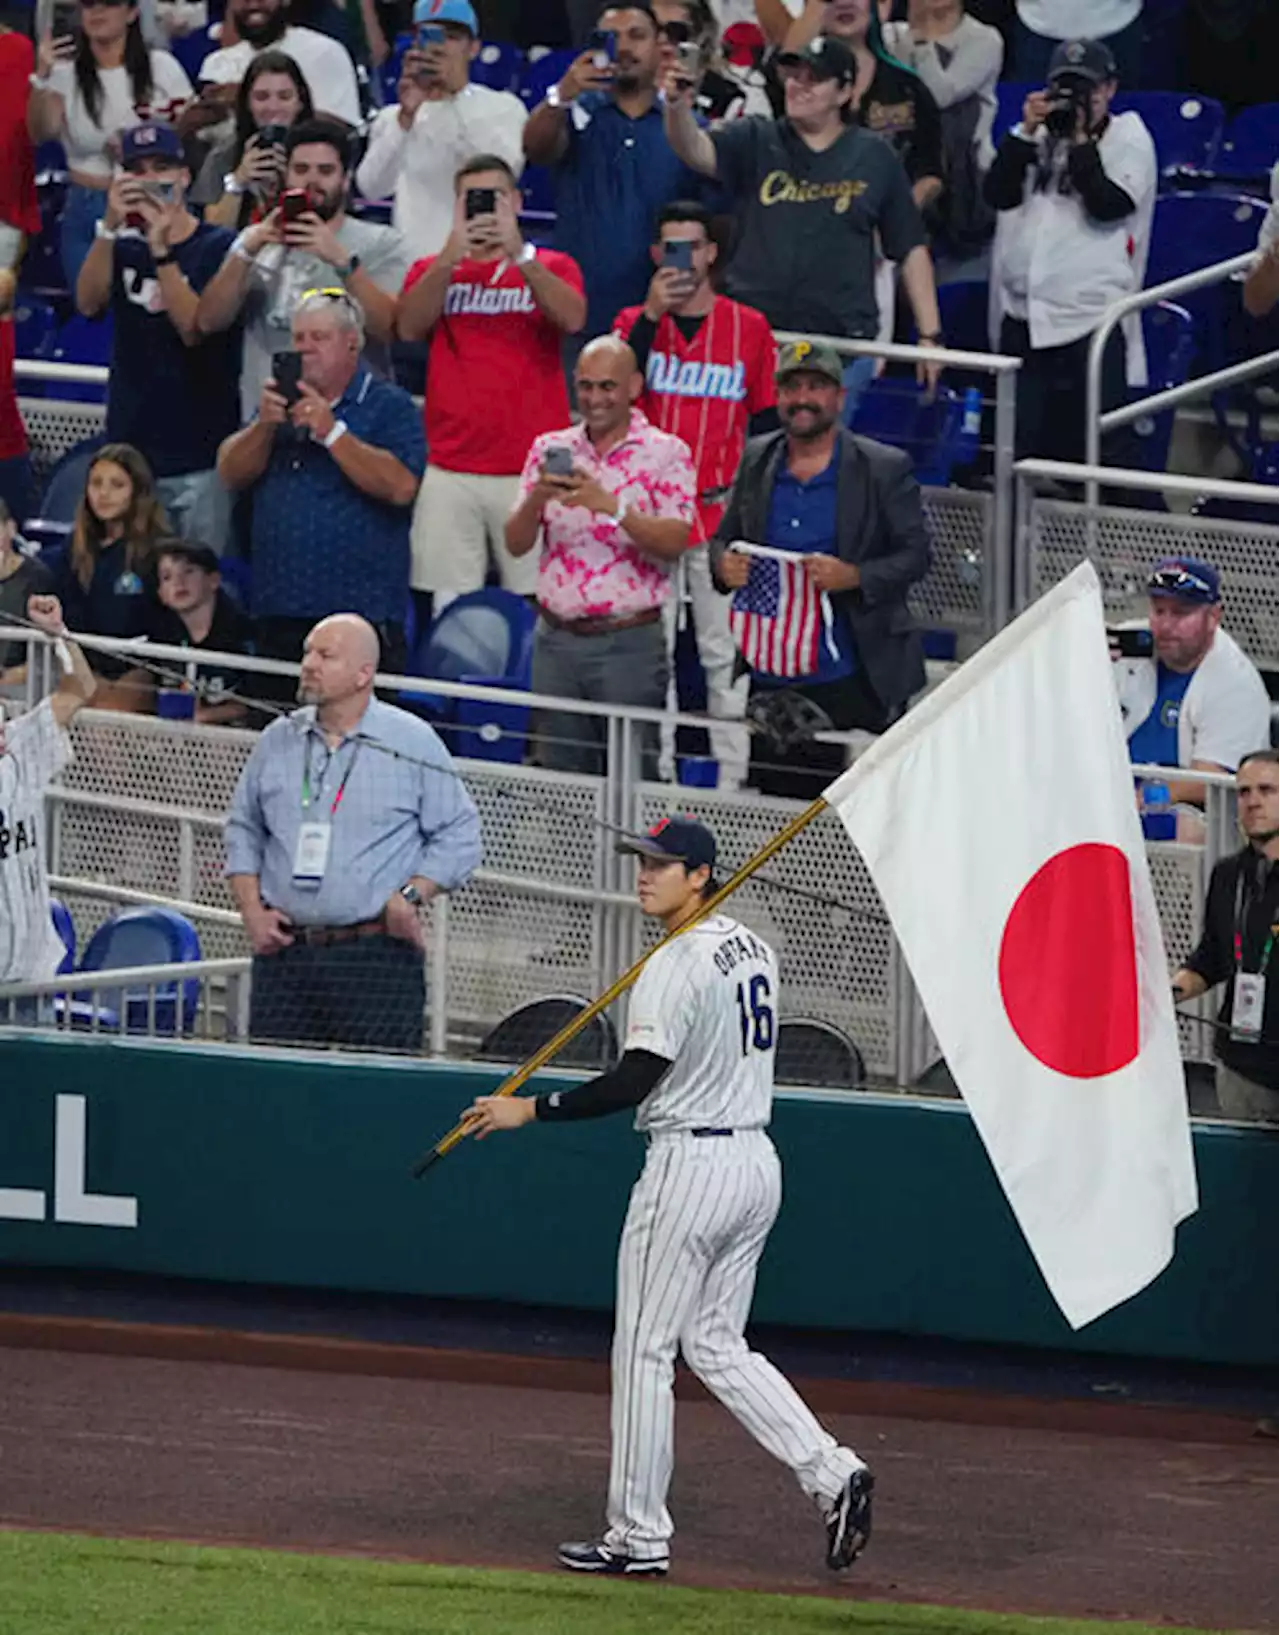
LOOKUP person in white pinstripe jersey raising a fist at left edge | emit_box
[0,597,95,983]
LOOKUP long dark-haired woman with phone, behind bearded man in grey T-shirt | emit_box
[186,51,316,231]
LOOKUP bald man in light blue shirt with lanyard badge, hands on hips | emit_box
[226,613,481,1053]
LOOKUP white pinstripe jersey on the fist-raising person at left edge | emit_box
[0,698,72,983]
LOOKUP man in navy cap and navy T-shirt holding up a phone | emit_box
[75,124,240,554]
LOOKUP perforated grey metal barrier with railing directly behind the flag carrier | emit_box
[0,626,1236,1094]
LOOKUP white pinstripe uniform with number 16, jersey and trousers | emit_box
[605,914,863,1561]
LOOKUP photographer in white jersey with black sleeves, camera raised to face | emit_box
[984,39,1157,464]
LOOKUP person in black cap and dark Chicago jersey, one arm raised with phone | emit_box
[665,34,942,400]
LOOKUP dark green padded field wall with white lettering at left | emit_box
[0,1037,1280,1368]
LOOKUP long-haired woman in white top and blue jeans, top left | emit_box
[26,0,191,289]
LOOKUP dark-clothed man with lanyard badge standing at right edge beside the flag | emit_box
[1174,749,1280,1123]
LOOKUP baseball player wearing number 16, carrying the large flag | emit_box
[466,818,873,1576]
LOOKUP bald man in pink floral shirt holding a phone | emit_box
[507,335,698,778]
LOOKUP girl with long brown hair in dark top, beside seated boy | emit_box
[54,443,172,714]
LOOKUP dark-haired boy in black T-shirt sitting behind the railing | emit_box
[154,540,253,726]
